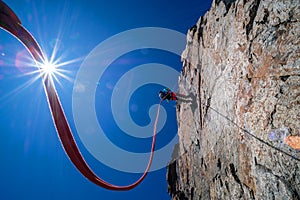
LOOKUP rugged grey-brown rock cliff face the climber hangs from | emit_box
[167,0,300,199]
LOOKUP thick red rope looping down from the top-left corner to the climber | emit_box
[0,0,162,190]
